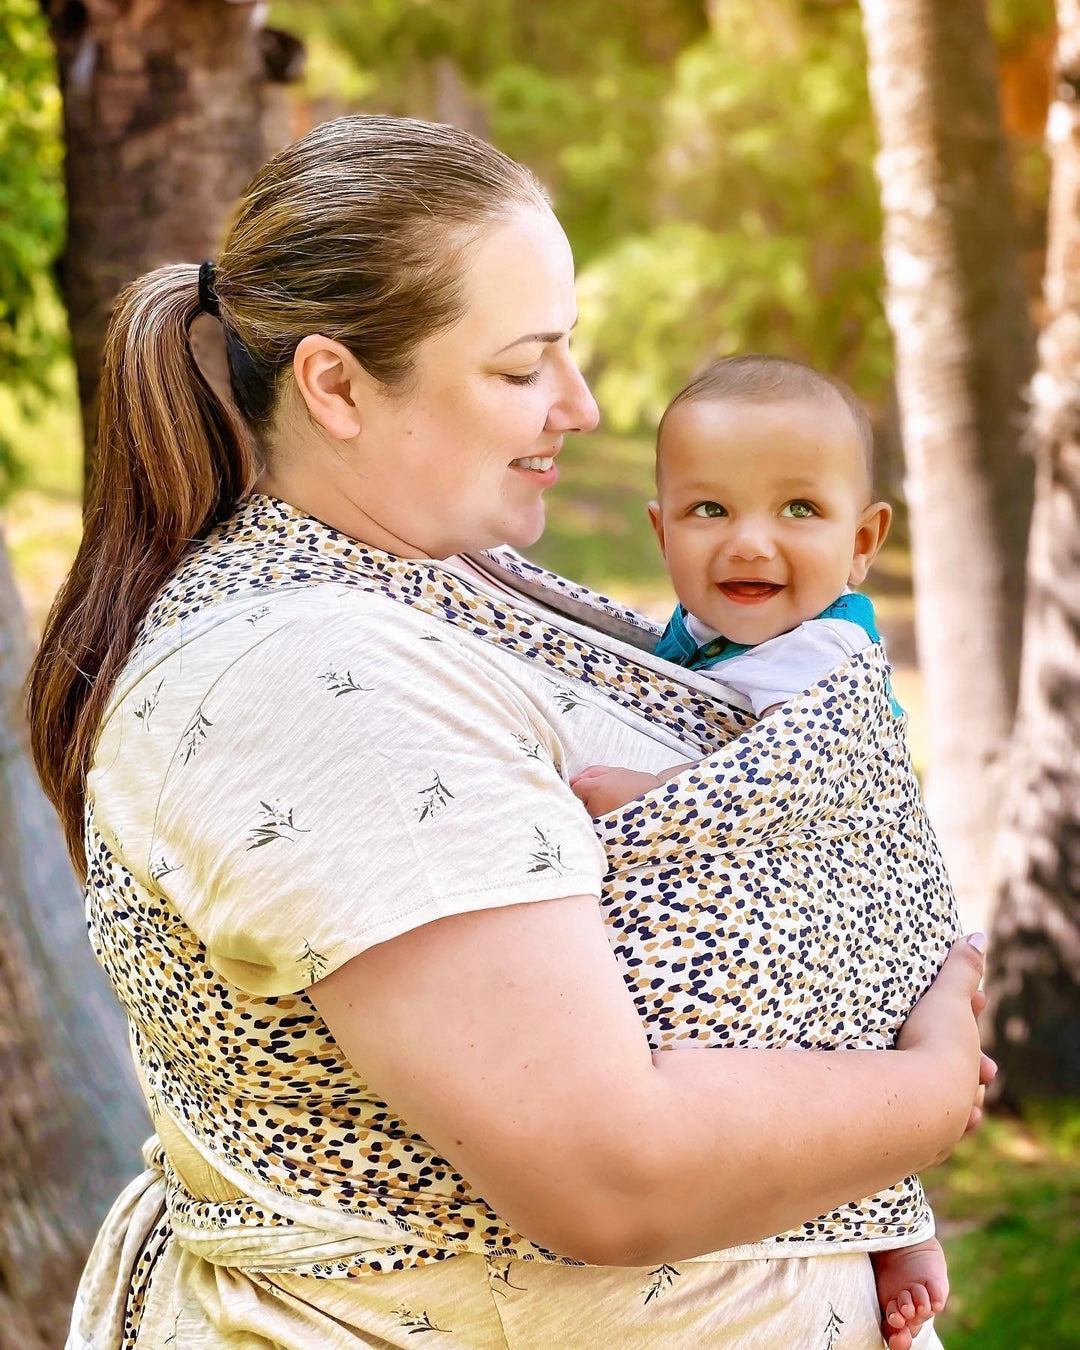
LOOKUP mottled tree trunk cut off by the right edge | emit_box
[987,0,1080,1106]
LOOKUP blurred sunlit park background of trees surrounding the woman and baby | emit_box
[0,0,1080,1350]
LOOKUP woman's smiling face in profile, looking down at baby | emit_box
[286,208,597,558]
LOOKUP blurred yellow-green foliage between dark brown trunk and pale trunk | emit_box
[273,0,891,431]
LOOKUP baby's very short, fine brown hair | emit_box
[656,352,873,489]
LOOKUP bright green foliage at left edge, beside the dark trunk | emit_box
[0,0,63,495]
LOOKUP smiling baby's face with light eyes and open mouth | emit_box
[649,398,891,645]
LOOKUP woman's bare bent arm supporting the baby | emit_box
[309,896,981,1265]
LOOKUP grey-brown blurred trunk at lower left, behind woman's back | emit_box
[0,521,151,1350]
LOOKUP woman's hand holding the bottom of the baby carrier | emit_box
[896,933,998,1161]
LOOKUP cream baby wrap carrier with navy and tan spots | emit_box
[73,497,956,1345]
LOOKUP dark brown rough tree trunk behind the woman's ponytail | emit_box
[43,0,302,459]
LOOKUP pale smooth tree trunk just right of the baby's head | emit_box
[863,0,1034,926]
